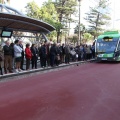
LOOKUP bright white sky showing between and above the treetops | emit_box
[10,0,120,29]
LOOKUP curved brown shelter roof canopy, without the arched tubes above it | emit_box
[0,13,55,33]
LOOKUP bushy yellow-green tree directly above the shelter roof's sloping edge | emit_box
[25,0,61,41]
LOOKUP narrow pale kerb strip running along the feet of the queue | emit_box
[0,59,94,78]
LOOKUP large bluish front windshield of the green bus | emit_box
[96,41,117,53]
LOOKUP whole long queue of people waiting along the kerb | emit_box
[0,40,95,75]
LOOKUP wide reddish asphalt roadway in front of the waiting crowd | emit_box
[0,63,120,120]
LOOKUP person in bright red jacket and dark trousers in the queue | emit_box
[25,44,32,70]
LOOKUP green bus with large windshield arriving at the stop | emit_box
[95,31,120,61]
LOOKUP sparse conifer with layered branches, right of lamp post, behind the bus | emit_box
[85,0,111,38]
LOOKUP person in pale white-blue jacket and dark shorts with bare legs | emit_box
[14,40,22,73]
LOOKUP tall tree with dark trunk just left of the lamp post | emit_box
[53,0,77,41]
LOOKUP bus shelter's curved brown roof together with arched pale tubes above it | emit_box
[0,4,55,41]
